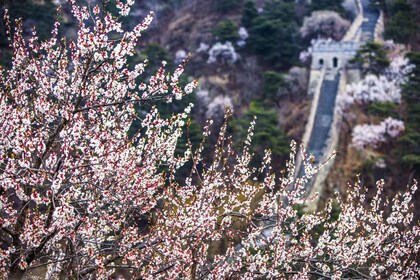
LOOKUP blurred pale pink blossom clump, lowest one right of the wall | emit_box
[352,117,405,150]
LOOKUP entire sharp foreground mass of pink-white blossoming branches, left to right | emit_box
[0,0,420,279]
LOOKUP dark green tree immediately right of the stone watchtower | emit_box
[352,42,390,75]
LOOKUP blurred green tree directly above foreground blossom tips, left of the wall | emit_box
[232,101,289,168]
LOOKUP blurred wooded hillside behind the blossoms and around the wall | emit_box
[0,0,420,212]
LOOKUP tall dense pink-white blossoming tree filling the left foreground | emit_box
[0,1,196,278]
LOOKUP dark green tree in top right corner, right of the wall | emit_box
[384,0,419,44]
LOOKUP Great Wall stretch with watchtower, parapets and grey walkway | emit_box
[296,0,383,209]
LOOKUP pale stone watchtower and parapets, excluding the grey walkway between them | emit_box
[296,0,384,210]
